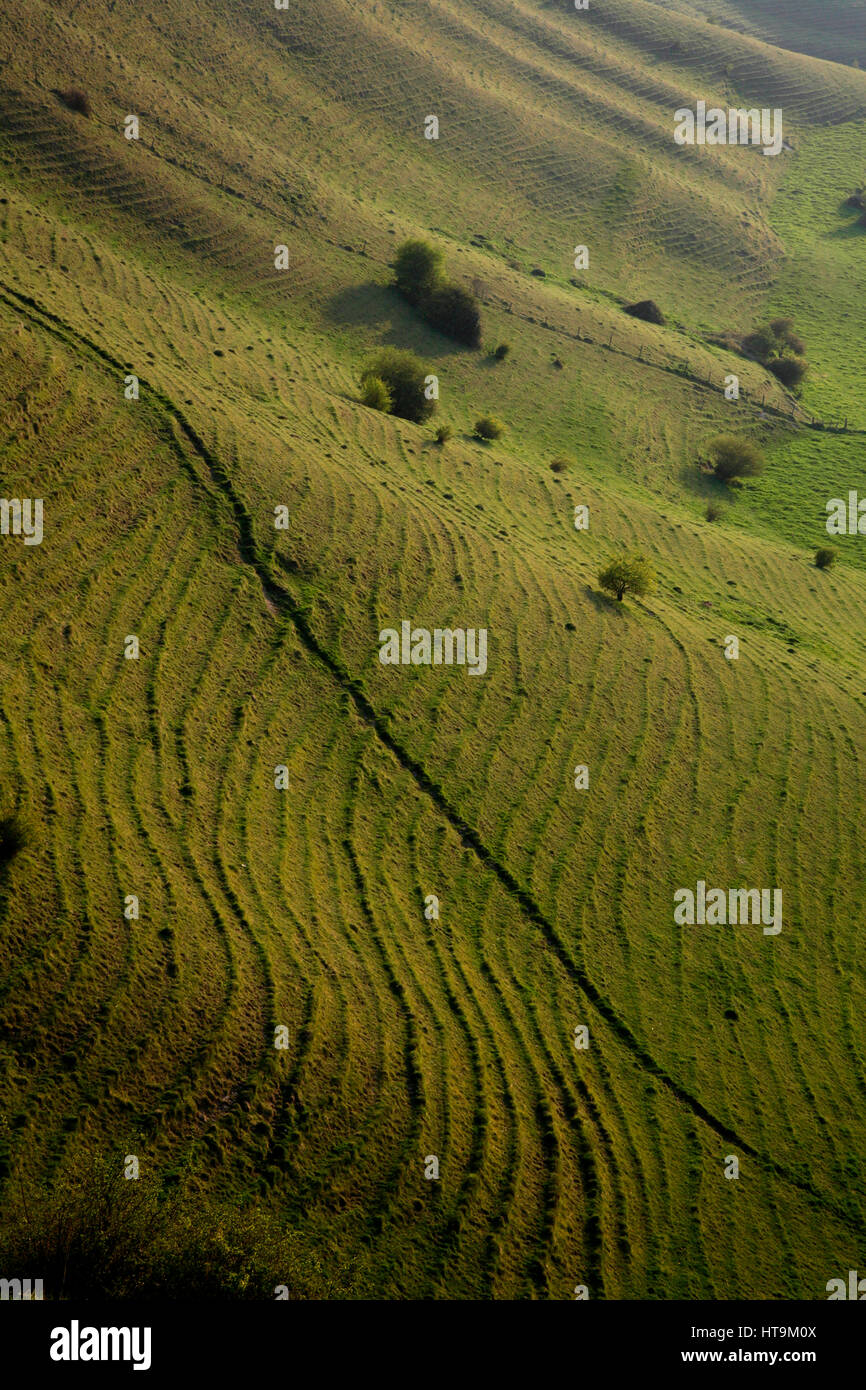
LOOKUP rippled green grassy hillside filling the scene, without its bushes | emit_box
[0,0,866,1298]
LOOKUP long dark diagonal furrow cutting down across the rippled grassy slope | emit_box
[0,281,865,1234]
